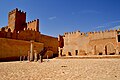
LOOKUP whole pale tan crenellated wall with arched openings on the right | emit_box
[58,30,120,56]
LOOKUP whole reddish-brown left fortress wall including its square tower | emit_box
[0,8,58,59]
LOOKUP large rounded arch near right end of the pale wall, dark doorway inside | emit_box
[105,43,115,55]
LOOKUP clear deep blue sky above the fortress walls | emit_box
[0,0,120,37]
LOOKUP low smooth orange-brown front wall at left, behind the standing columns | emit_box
[0,38,44,61]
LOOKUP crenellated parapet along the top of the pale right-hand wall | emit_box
[64,30,116,40]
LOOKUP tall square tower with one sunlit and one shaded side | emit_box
[8,8,27,32]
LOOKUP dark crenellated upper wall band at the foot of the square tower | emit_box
[0,27,40,41]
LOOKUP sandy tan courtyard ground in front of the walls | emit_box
[0,59,120,80]
